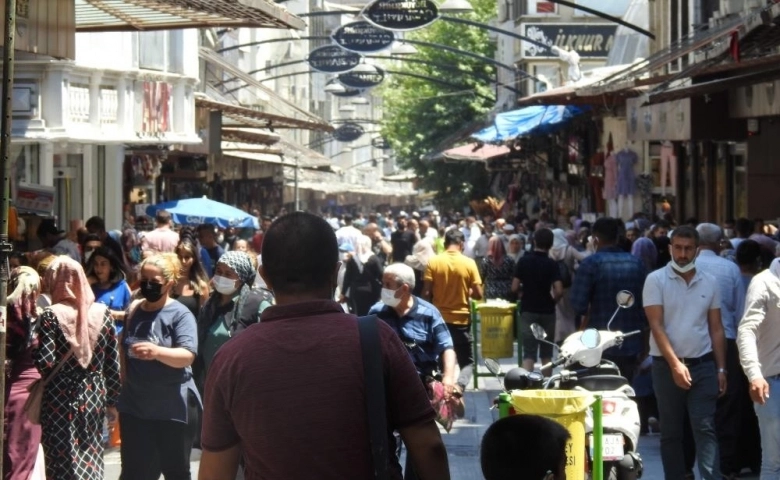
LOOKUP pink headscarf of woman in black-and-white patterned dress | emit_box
[46,256,108,368]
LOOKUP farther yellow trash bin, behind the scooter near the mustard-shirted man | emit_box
[477,300,517,358]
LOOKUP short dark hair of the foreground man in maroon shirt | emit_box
[263,212,339,294]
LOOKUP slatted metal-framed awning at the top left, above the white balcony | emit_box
[75,0,306,32]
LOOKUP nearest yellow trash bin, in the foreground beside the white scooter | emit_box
[512,390,594,480]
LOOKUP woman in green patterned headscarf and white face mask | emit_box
[195,250,273,393]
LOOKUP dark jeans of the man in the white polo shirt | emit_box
[653,357,721,480]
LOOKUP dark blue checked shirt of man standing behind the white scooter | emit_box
[570,247,647,356]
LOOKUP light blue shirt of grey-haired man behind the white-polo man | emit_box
[696,250,747,340]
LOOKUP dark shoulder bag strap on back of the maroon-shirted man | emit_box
[358,315,390,480]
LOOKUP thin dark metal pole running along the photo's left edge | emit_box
[0,0,16,471]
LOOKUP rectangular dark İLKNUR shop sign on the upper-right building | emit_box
[520,23,617,58]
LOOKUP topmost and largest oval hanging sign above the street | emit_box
[363,0,439,32]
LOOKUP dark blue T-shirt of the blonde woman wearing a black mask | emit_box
[117,301,199,423]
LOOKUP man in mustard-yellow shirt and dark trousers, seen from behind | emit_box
[422,228,483,393]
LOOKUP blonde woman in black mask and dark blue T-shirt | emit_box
[117,253,201,480]
